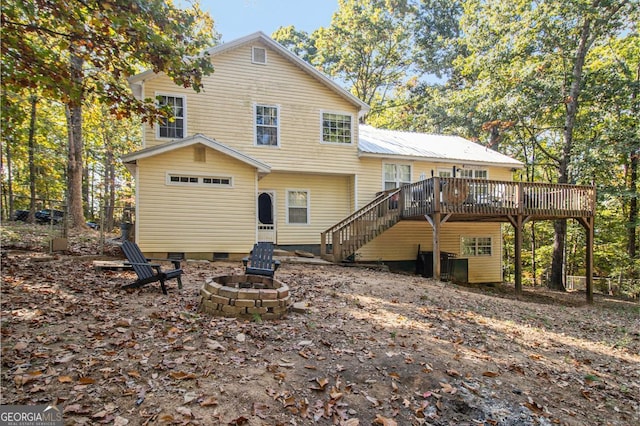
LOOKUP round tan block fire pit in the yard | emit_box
[199,275,291,319]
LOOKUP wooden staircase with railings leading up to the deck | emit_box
[320,188,401,262]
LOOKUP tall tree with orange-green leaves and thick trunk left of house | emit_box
[1,0,217,226]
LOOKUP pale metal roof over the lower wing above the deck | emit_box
[358,125,524,168]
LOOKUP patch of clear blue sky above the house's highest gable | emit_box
[200,0,338,42]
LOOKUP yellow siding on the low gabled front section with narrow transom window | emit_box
[136,147,256,253]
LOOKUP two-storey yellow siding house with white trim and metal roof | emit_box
[123,32,522,282]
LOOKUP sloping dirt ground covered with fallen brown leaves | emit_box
[0,225,640,426]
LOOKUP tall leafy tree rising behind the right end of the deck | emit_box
[436,0,637,289]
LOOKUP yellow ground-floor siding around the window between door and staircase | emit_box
[259,172,353,245]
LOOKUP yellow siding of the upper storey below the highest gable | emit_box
[144,40,358,173]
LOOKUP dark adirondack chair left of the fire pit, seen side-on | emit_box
[122,241,182,294]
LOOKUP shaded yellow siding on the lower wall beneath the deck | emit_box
[356,221,502,283]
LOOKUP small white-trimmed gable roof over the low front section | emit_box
[122,133,271,174]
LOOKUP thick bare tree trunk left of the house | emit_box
[66,52,86,228]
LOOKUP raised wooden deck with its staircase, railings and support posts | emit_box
[320,177,596,302]
